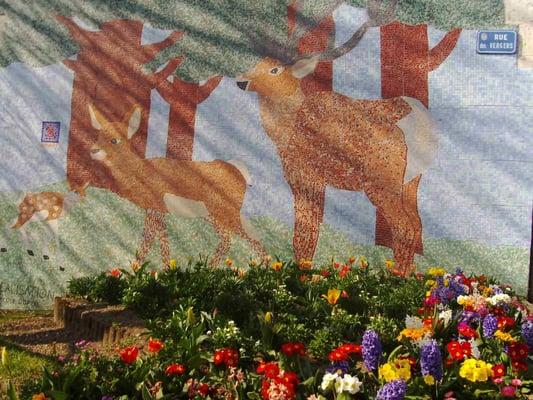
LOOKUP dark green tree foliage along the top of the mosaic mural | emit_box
[0,0,504,71]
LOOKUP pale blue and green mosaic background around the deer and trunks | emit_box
[0,2,533,309]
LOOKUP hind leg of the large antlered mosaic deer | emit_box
[364,182,415,275]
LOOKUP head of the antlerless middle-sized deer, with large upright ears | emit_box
[89,105,141,165]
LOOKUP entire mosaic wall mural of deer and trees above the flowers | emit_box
[0,0,533,308]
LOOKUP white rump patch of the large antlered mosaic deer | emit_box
[396,97,439,183]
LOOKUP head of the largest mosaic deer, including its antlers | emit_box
[236,0,392,97]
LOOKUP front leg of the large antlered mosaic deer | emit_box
[291,182,326,261]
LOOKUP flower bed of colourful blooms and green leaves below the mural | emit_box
[5,258,533,400]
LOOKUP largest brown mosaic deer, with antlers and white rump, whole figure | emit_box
[237,0,437,275]
